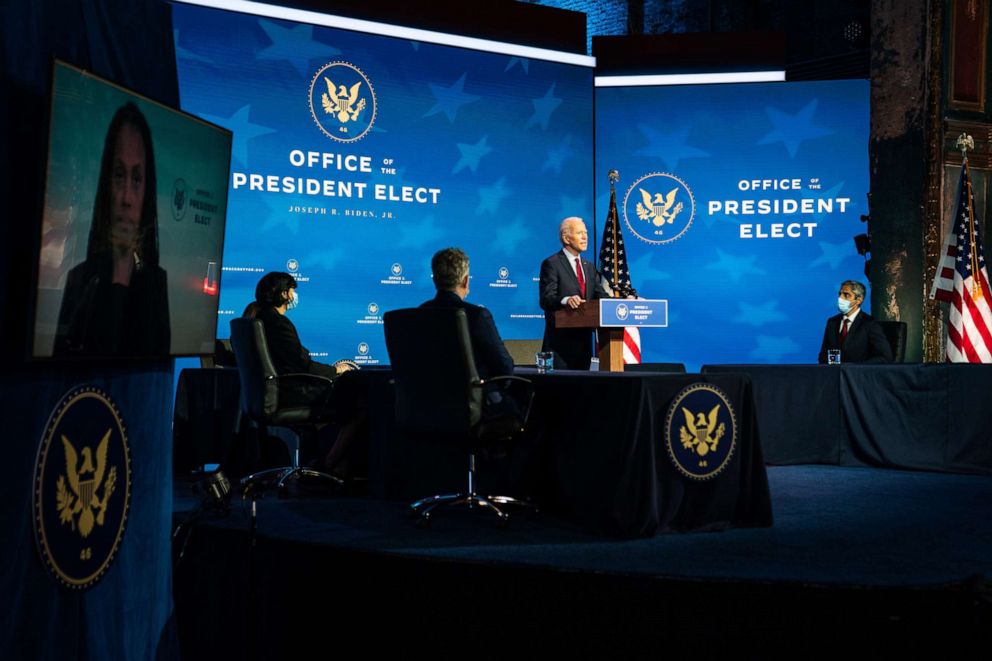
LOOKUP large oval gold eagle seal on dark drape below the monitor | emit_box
[34,386,131,589]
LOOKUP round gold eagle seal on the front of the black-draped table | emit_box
[665,383,737,480]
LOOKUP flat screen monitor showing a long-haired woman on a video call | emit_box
[32,60,232,359]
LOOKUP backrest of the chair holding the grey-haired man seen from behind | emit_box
[382,308,482,436]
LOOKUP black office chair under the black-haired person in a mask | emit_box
[231,317,342,493]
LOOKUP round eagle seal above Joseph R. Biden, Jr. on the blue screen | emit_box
[310,61,376,142]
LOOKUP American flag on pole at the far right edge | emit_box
[930,158,992,363]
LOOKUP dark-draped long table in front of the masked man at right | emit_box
[703,364,992,474]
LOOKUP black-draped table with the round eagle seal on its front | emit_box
[369,369,772,537]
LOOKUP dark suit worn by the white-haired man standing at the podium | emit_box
[540,250,607,370]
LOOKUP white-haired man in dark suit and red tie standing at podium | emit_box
[540,216,608,370]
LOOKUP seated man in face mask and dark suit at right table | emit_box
[819,280,892,364]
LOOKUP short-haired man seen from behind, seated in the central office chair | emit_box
[420,248,513,380]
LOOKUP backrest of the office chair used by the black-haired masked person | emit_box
[231,317,279,421]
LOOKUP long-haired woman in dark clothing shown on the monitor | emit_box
[54,103,170,356]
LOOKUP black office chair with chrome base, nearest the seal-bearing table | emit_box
[383,308,534,526]
